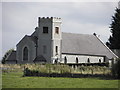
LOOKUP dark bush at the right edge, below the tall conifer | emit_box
[111,58,120,79]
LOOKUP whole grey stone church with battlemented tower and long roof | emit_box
[6,17,118,64]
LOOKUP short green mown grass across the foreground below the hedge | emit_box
[2,72,118,88]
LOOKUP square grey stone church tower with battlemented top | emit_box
[37,17,62,63]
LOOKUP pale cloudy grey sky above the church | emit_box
[0,2,118,58]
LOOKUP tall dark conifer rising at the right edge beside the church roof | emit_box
[106,8,120,49]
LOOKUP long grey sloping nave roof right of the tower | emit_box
[62,33,117,59]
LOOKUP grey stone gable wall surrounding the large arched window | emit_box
[16,36,36,64]
